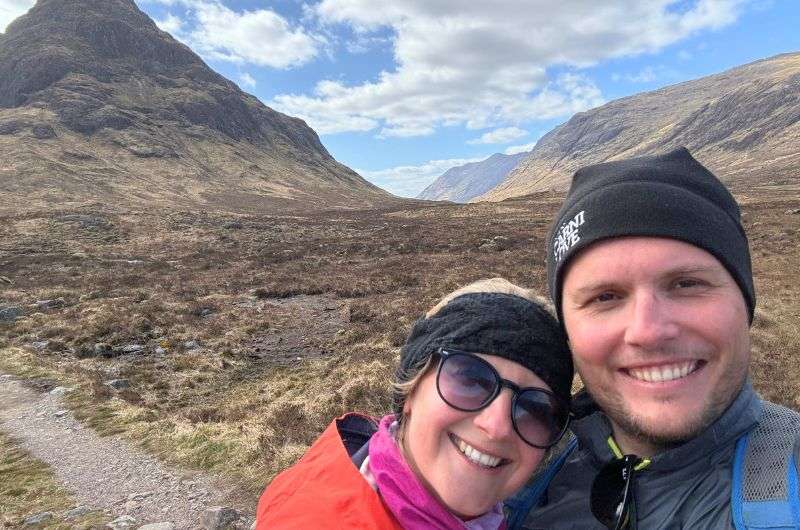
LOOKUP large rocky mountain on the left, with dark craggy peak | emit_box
[0,0,397,210]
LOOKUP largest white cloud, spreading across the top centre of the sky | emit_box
[270,0,743,137]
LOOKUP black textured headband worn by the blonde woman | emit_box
[394,292,573,416]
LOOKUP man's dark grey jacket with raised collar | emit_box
[525,382,800,530]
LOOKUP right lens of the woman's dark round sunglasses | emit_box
[514,390,569,447]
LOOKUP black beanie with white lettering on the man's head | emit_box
[547,147,756,322]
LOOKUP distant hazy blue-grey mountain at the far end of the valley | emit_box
[417,153,528,202]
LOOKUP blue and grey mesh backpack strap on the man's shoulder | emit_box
[731,401,800,530]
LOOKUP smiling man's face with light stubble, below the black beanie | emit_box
[562,237,750,453]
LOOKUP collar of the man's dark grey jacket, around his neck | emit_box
[572,379,763,471]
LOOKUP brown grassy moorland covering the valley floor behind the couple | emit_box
[0,187,800,504]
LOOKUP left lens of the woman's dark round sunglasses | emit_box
[438,354,498,410]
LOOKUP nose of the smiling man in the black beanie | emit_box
[625,290,678,349]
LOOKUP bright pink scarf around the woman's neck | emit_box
[369,414,506,530]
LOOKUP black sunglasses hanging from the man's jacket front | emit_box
[589,455,649,530]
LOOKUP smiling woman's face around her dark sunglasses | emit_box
[403,355,549,519]
